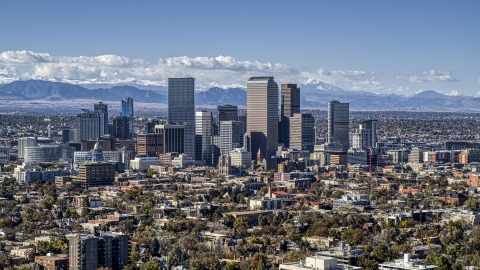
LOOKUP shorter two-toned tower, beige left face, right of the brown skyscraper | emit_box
[290,113,315,152]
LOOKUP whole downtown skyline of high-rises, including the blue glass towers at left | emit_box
[75,76,376,170]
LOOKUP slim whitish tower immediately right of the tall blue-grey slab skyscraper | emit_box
[195,111,213,166]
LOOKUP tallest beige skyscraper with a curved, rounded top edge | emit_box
[247,76,278,169]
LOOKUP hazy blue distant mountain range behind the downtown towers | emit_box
[0,80,480,111]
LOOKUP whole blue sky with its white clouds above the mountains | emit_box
[0,1,480,95]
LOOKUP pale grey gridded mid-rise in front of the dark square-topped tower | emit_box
[220,121,245,155]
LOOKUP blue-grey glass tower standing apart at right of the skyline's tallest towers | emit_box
[327,100,350,152]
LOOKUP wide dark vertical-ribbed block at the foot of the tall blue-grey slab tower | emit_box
[155,124,185,154]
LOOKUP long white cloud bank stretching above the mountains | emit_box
[0,51,464,93]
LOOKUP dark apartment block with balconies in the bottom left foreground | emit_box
[68,232,129,270]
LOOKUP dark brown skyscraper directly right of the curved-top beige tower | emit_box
[279,83,300,147]
